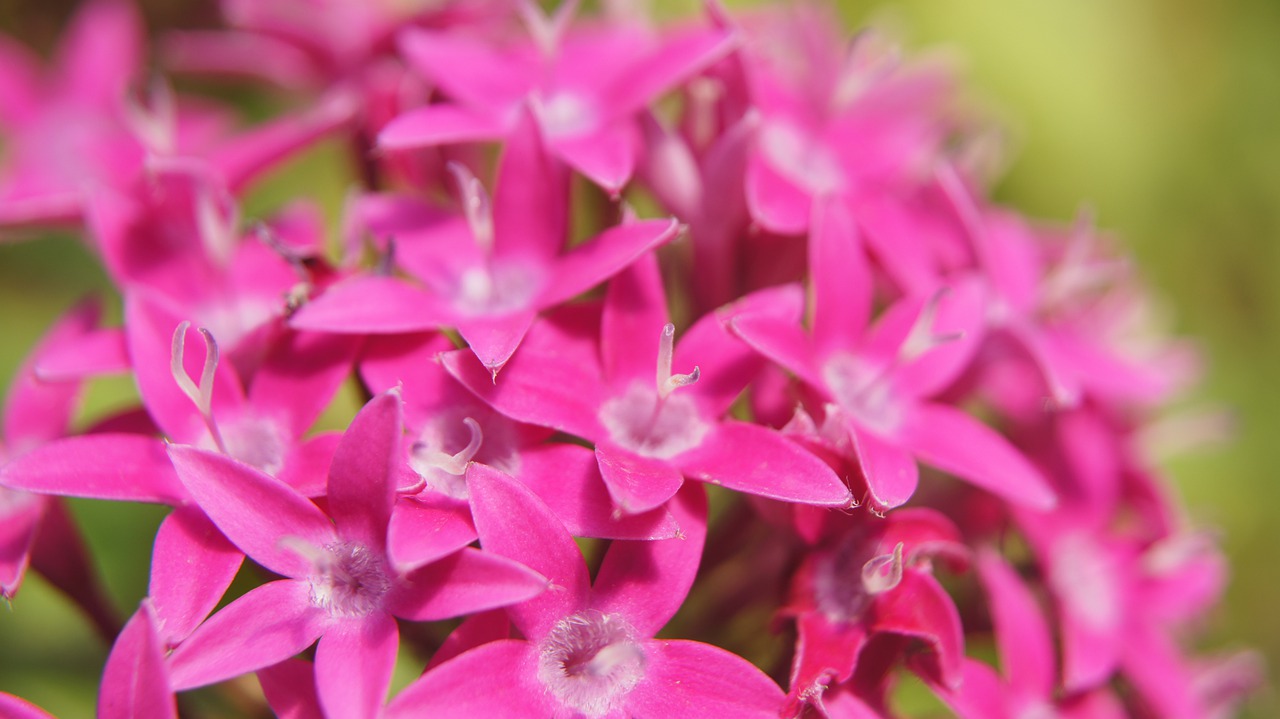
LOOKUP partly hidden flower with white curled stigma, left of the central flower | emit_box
[360,335,678,540]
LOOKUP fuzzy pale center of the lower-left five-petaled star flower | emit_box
[308,542,392,617]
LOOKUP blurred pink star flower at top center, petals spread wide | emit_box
[378,1,732,196]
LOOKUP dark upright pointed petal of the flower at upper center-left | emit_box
[493,110,568,262]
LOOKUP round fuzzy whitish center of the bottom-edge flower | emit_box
[538,609,645,719]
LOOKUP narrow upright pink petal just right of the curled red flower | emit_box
[978,550,1057,699]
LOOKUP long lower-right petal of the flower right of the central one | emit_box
[897,404,1057,509]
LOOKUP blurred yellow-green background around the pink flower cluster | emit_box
[0,0,1280,718]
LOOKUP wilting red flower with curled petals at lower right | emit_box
[785,509,968,716]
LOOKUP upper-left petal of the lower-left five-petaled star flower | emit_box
[169,445,338,577]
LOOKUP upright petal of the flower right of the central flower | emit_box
[809,198,873,352]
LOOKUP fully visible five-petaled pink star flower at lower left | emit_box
[168,393,545,716]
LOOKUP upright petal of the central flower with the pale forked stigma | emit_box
[600,252,670,386]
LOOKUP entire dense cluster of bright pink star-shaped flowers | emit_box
[0,0,1256,719]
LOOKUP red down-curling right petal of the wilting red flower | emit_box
[874,571,964,688]
